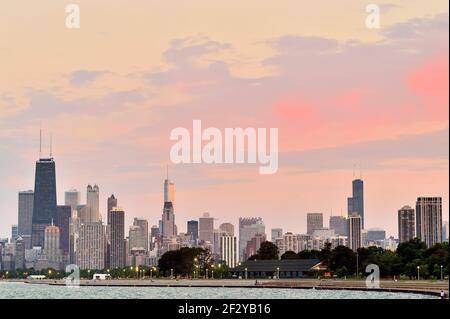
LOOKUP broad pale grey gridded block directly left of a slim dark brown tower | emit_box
[76,222,105,269]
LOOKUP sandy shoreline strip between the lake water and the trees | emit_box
[0,279,449,299]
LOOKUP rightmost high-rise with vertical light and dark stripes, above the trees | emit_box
[416,197,442,247]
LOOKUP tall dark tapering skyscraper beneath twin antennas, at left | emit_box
[31,158,56,247]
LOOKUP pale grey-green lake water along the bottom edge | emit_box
[0,282,437,299]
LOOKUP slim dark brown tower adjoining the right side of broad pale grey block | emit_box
[108,206,125,268]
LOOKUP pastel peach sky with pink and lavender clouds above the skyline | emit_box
[0,0,449,237]
